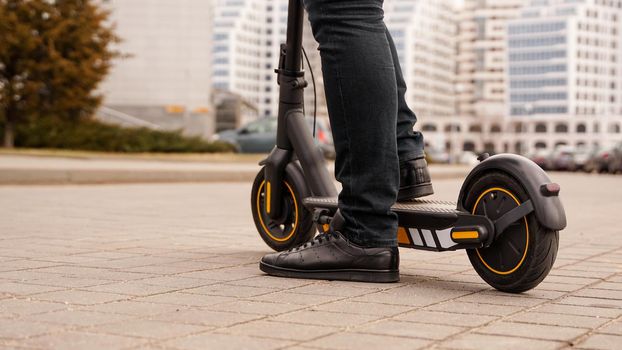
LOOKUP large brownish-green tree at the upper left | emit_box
[0,0,119,147]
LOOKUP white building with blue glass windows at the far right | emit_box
[507,0,622,152]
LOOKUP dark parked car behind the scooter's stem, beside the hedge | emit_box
[214,117,335,159]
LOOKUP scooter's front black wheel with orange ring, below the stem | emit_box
[251,165,316,251]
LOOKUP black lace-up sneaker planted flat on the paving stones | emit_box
[259,232,400,282]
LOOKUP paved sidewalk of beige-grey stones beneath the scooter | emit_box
[0,174,622,350]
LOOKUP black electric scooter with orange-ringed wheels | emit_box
[251,0,566,293]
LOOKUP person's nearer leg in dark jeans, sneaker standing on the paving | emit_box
[260,0,400,282]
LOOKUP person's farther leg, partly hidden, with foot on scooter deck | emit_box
[385,28,434,201]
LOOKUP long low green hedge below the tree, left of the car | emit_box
[0,118,233,153]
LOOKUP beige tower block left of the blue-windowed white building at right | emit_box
[421,0,528,158]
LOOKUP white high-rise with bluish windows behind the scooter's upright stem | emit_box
[212,0,328,123]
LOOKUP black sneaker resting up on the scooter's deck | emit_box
[397,158,434,202]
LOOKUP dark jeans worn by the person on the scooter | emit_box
[304,0,423,247]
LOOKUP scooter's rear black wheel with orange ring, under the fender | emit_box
[465,172,559,293]
